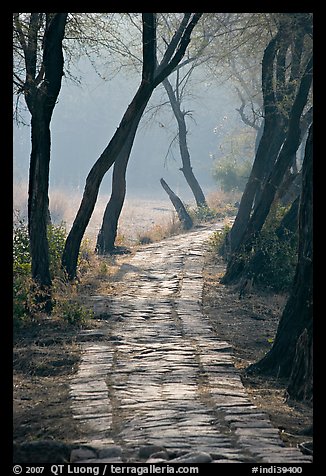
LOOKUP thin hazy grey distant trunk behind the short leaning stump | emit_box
[163,78,207,207]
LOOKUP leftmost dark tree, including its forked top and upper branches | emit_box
[14,13,67,311]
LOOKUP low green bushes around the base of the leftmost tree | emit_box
[13,213,92,333]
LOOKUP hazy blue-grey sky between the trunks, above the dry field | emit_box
[14,55,244,201]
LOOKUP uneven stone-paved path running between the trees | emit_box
[70,225,311,463]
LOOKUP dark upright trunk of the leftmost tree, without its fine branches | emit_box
[25,13,67,312]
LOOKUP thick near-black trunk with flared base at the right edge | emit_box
[247,126,313,390]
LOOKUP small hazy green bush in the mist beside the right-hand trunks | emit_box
[213,157,252,192]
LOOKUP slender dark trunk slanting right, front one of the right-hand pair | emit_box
[222,58,312,284]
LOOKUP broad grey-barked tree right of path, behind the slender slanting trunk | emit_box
[225,14,311,255]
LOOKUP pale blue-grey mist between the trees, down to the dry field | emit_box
[13,58,250,240]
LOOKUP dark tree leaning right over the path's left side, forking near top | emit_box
[62,13,202,272]
